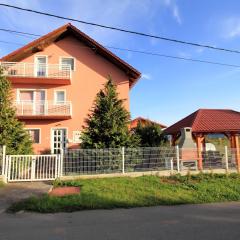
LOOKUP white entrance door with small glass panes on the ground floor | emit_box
[52,128,67,154]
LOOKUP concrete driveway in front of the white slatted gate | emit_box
[0,182,51,214]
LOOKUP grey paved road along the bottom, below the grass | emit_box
[0,203,240,240]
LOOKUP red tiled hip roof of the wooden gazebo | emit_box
[164,109,240,135]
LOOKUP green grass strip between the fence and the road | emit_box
[9,174,240,213]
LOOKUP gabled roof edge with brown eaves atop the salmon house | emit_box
[0,23,141,87]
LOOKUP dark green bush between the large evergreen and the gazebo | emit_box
[133,122,166,147]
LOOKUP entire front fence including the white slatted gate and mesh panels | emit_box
[1,147,239,182]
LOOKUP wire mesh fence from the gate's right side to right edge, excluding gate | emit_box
[63,147,237,175]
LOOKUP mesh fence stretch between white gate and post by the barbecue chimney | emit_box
[63,148,176,175]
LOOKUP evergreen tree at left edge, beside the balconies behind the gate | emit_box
[0,68,32,154]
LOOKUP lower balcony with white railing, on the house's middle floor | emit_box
[14,101,72,119]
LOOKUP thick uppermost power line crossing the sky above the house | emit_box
[0,3,240,53]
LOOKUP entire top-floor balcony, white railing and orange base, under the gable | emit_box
[0,62,72,85]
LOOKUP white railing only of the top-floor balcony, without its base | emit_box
[0,62,72,79]
